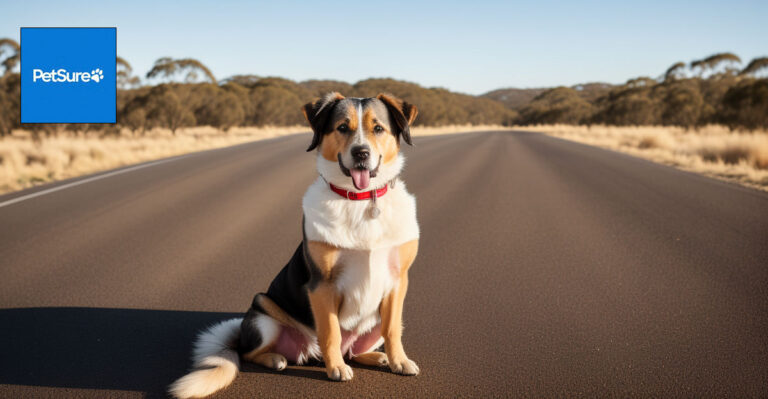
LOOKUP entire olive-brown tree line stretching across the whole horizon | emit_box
[0,39,768,136]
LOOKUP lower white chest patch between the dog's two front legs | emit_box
[335,247,400,334]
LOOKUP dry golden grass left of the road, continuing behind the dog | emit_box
[0,126,516,193]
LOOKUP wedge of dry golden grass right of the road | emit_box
[520,125,768,191]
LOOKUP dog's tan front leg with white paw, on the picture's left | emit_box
[307,242,352,381]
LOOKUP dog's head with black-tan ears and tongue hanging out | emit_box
[304,93,418,191]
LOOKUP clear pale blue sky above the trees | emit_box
[0,0,768,94]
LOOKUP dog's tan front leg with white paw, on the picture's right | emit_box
[380,240,419,375]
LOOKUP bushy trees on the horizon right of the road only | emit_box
[516,53,768,130]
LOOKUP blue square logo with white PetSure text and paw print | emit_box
[21,28,117,123]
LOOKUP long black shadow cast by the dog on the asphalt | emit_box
[0,308,325,397]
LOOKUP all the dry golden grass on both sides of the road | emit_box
[0,125,768,193]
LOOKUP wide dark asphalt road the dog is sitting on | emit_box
[0,132,768,398]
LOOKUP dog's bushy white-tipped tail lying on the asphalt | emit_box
[168,319,243,399]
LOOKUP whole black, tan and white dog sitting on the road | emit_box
[169,93,419,398]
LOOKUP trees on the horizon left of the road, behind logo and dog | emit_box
[0,39,516,135]
